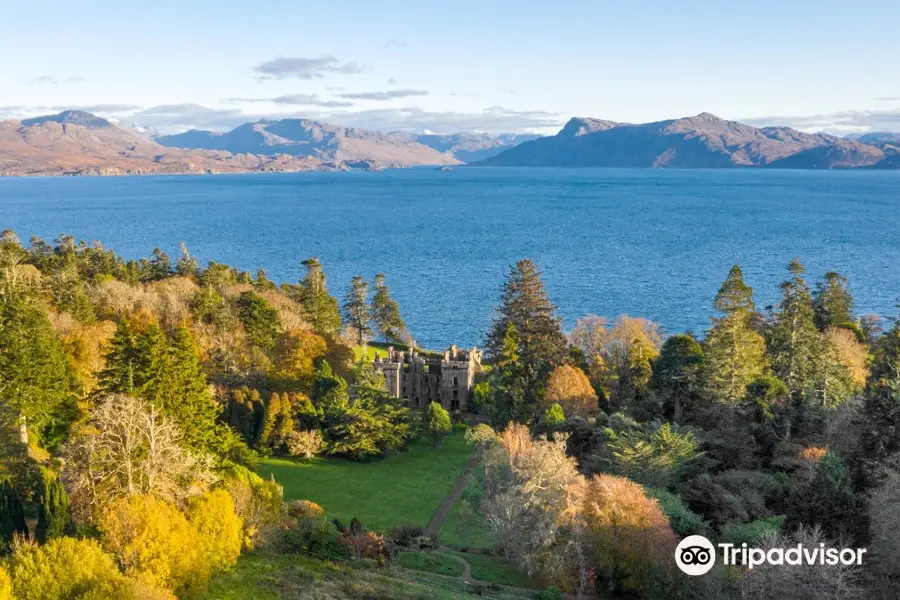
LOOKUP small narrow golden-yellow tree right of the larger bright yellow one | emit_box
[188,489,244,571]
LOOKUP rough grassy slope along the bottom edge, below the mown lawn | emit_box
[201,552,521,600]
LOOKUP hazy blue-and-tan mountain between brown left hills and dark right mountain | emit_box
[155,119,459,166]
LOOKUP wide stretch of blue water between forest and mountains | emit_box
[0,168,900,348]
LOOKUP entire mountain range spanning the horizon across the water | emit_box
[0,110,900,175]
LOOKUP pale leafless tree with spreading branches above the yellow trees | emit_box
[63,395,215,522]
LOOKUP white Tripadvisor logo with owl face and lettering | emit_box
[675,535,866,575]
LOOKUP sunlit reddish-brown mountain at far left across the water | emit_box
[0,110,336,175]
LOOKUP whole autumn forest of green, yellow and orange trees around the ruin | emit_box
[0,231,900,600]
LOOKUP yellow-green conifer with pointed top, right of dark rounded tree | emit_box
[704,265,766,406]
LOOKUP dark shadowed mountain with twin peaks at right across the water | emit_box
[477,113,897,169]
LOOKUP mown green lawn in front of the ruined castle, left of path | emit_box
[259,429,474,532]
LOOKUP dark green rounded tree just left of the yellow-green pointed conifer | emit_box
[650,335,706,423]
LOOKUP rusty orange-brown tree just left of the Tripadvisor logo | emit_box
[582,475,676,593]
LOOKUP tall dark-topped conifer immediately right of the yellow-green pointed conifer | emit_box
[769,259,824,402]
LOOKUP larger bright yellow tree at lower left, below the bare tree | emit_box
[100,496,210,596]
